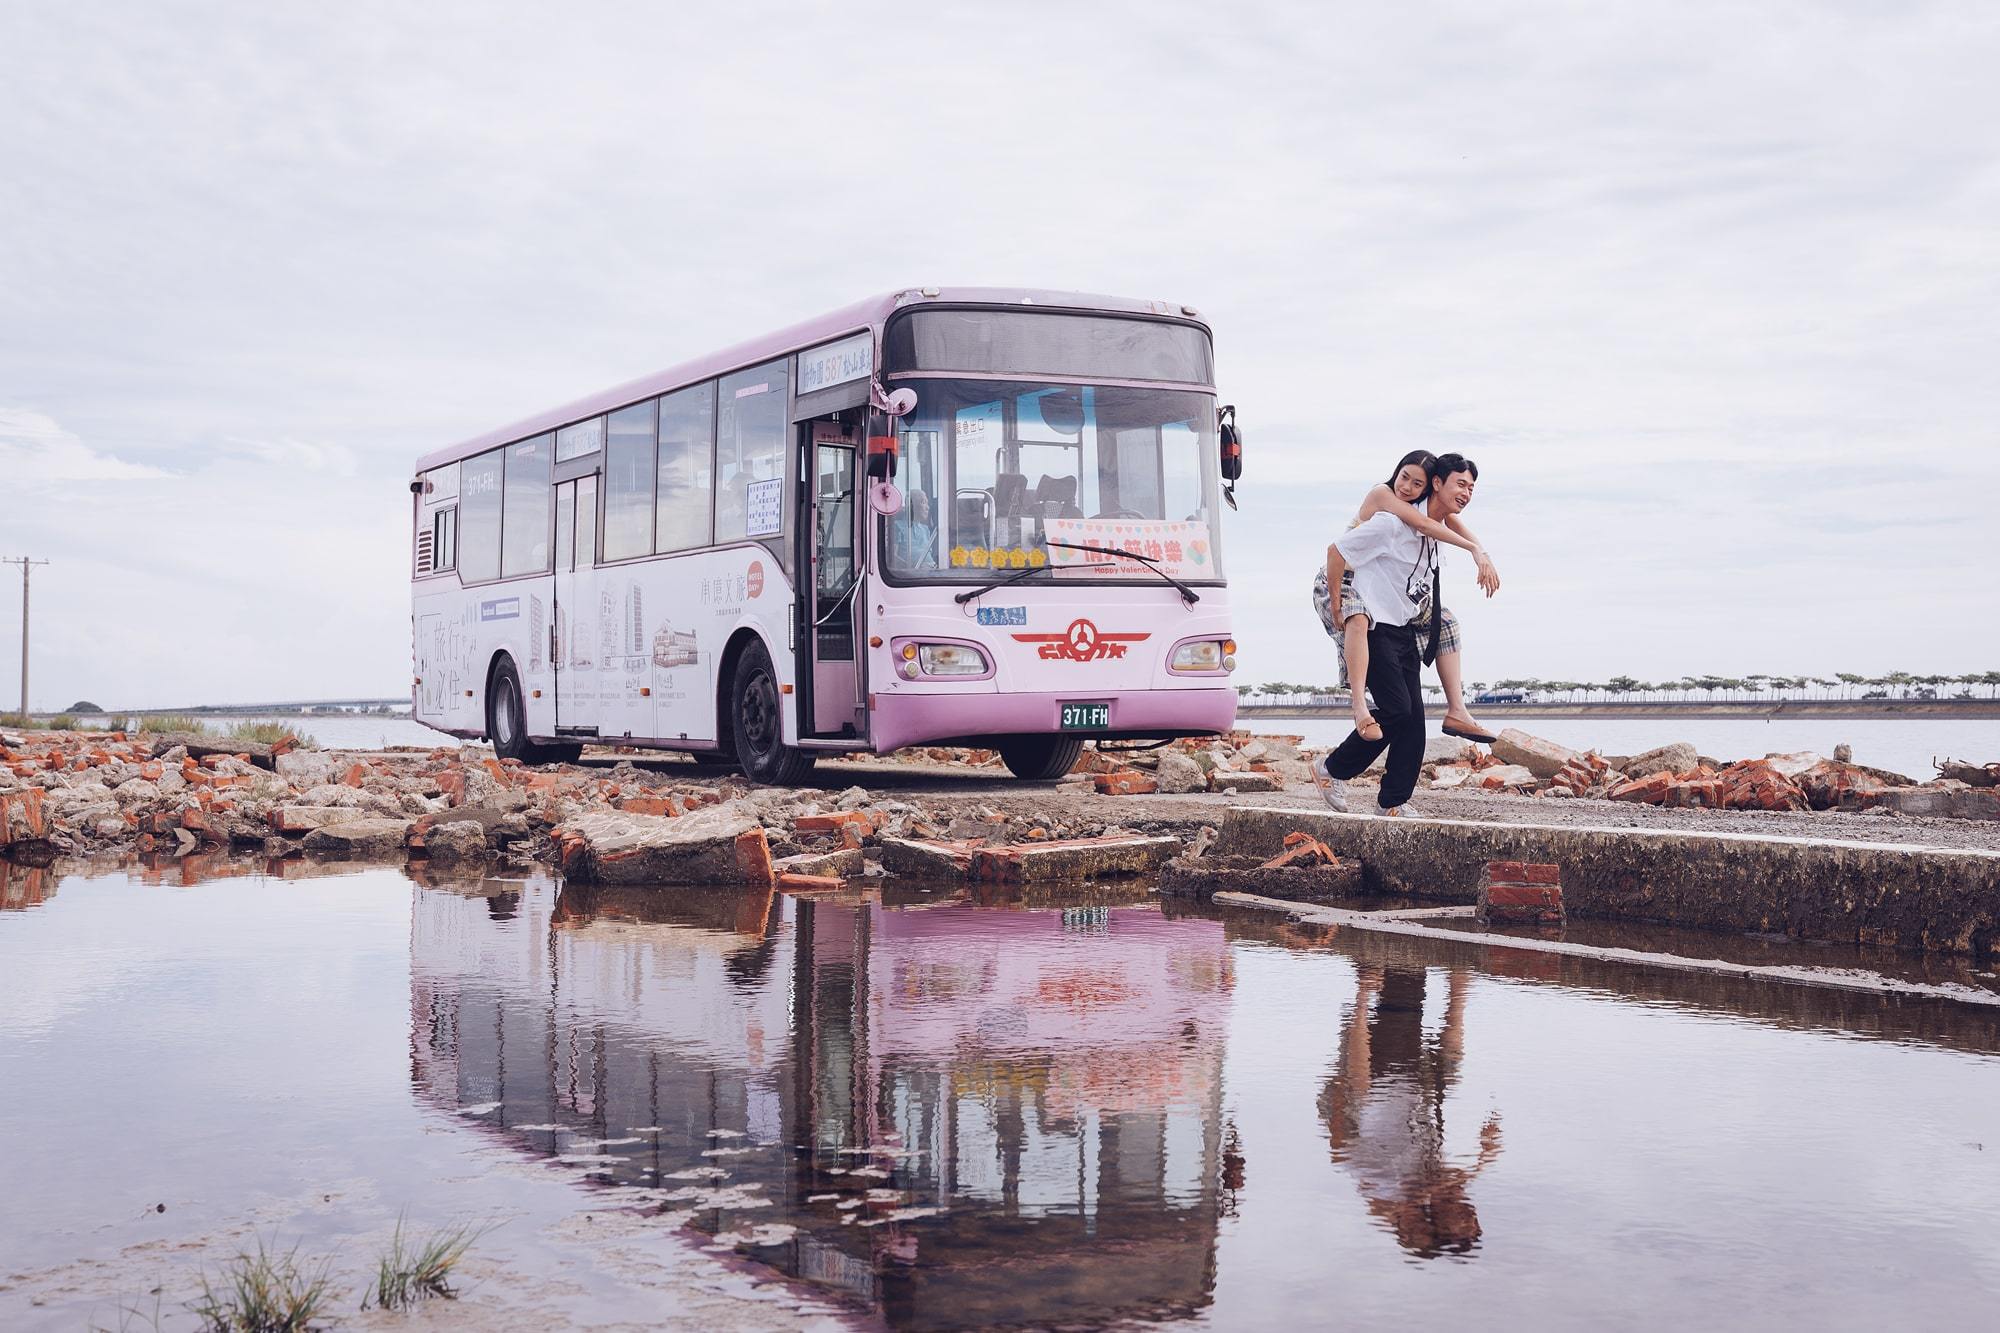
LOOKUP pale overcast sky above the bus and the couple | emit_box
[0,0,2000,709]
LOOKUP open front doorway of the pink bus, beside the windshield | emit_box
[798,420,862,741]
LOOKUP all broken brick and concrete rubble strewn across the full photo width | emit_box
[0,729,2000,885]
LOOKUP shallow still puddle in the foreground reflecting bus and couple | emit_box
[0,867,2000,1329]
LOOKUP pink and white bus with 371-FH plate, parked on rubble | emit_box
[410,286,1238,783]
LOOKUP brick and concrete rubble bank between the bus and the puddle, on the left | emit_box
[0,733,1224,876]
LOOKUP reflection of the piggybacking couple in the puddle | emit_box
[1320,965,1500,1259]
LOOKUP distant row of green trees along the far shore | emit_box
[1236,671,2000,705]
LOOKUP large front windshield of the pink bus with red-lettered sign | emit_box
[882,378,1222,582]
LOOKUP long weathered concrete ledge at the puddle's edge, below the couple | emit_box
[1216,807,2000,959]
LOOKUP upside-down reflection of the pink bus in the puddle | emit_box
[412,883,1242,1327]
